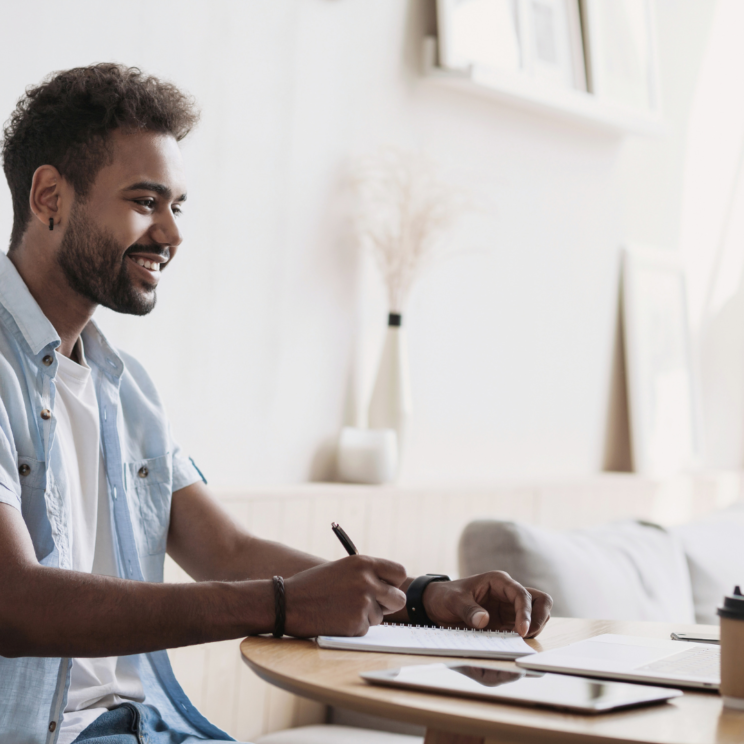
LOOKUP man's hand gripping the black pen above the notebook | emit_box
[284,555,406,638]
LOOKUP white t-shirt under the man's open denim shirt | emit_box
[54,341,145,744]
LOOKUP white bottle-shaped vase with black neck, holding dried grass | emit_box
[368,313,413,467]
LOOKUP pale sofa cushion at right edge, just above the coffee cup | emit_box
[672,501,744,625]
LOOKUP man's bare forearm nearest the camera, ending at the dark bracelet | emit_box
[0,566,274,657]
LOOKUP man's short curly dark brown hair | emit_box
[2,63,199,250]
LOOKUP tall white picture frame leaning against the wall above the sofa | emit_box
[622,245,703,477]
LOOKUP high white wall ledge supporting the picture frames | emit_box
[424,37,664,135]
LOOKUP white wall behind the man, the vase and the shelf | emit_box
[0,0,714,488]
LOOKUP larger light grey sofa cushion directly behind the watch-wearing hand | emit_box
[460,520,695,623]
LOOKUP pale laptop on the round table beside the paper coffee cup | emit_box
[517,634,721,690]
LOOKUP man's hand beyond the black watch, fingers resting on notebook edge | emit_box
[423,571,553,638]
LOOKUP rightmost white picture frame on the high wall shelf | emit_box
[581,0,661,115]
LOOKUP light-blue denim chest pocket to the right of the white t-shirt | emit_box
[124,454,173,555]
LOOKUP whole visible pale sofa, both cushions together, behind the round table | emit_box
[460,501,744,624]
